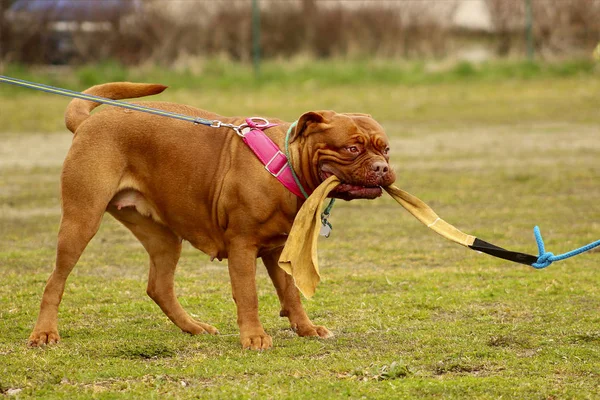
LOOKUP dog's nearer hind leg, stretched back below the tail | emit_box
[28,135,125,347]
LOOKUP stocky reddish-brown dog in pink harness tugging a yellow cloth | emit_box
[29,83,395,349]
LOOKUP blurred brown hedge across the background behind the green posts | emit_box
[0,0,600,65]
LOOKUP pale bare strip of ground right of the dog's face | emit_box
[391,124,600,170]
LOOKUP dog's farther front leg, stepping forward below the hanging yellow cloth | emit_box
[262,249,333,338]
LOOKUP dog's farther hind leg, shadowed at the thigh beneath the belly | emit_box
[108,205,219,335]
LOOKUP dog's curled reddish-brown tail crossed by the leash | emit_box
[65,82,167,133]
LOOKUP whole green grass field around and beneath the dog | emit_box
[0,61,600,399]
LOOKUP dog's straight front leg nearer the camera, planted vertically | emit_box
[228,241,273,350]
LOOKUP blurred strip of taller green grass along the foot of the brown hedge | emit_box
[3,57,597,90]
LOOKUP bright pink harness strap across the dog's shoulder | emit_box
[240,118,305,199]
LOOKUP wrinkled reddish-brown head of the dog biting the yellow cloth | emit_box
[290,111,396,200]
